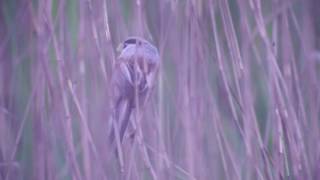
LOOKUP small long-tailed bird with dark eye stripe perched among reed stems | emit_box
[109,37,160,145]
